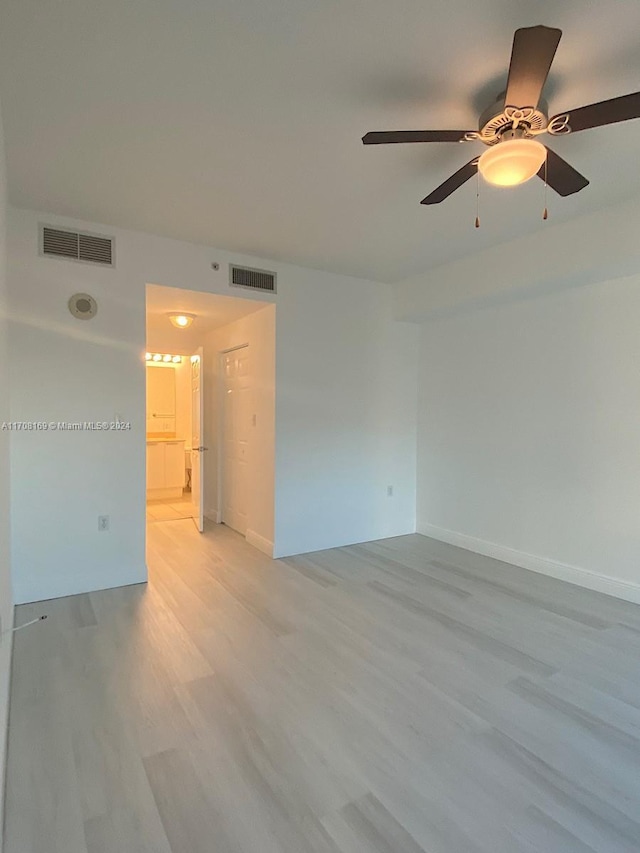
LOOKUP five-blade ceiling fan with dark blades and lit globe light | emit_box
[362,26,640,204]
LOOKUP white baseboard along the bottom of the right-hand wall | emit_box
[417,522,640,604]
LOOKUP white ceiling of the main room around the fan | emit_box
[0,0,640,281]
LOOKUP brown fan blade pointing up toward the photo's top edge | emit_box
[504,27,562,107]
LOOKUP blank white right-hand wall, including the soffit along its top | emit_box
[397,196,640,601]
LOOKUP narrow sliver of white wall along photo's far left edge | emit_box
[0,90,13,850]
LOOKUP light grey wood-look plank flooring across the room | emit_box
[6,520,640,853]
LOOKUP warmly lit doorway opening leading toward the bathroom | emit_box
[146,284,276,554]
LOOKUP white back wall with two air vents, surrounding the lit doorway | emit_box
[8,210,418,602]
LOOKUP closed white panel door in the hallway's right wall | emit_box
[222,346,251,535]
